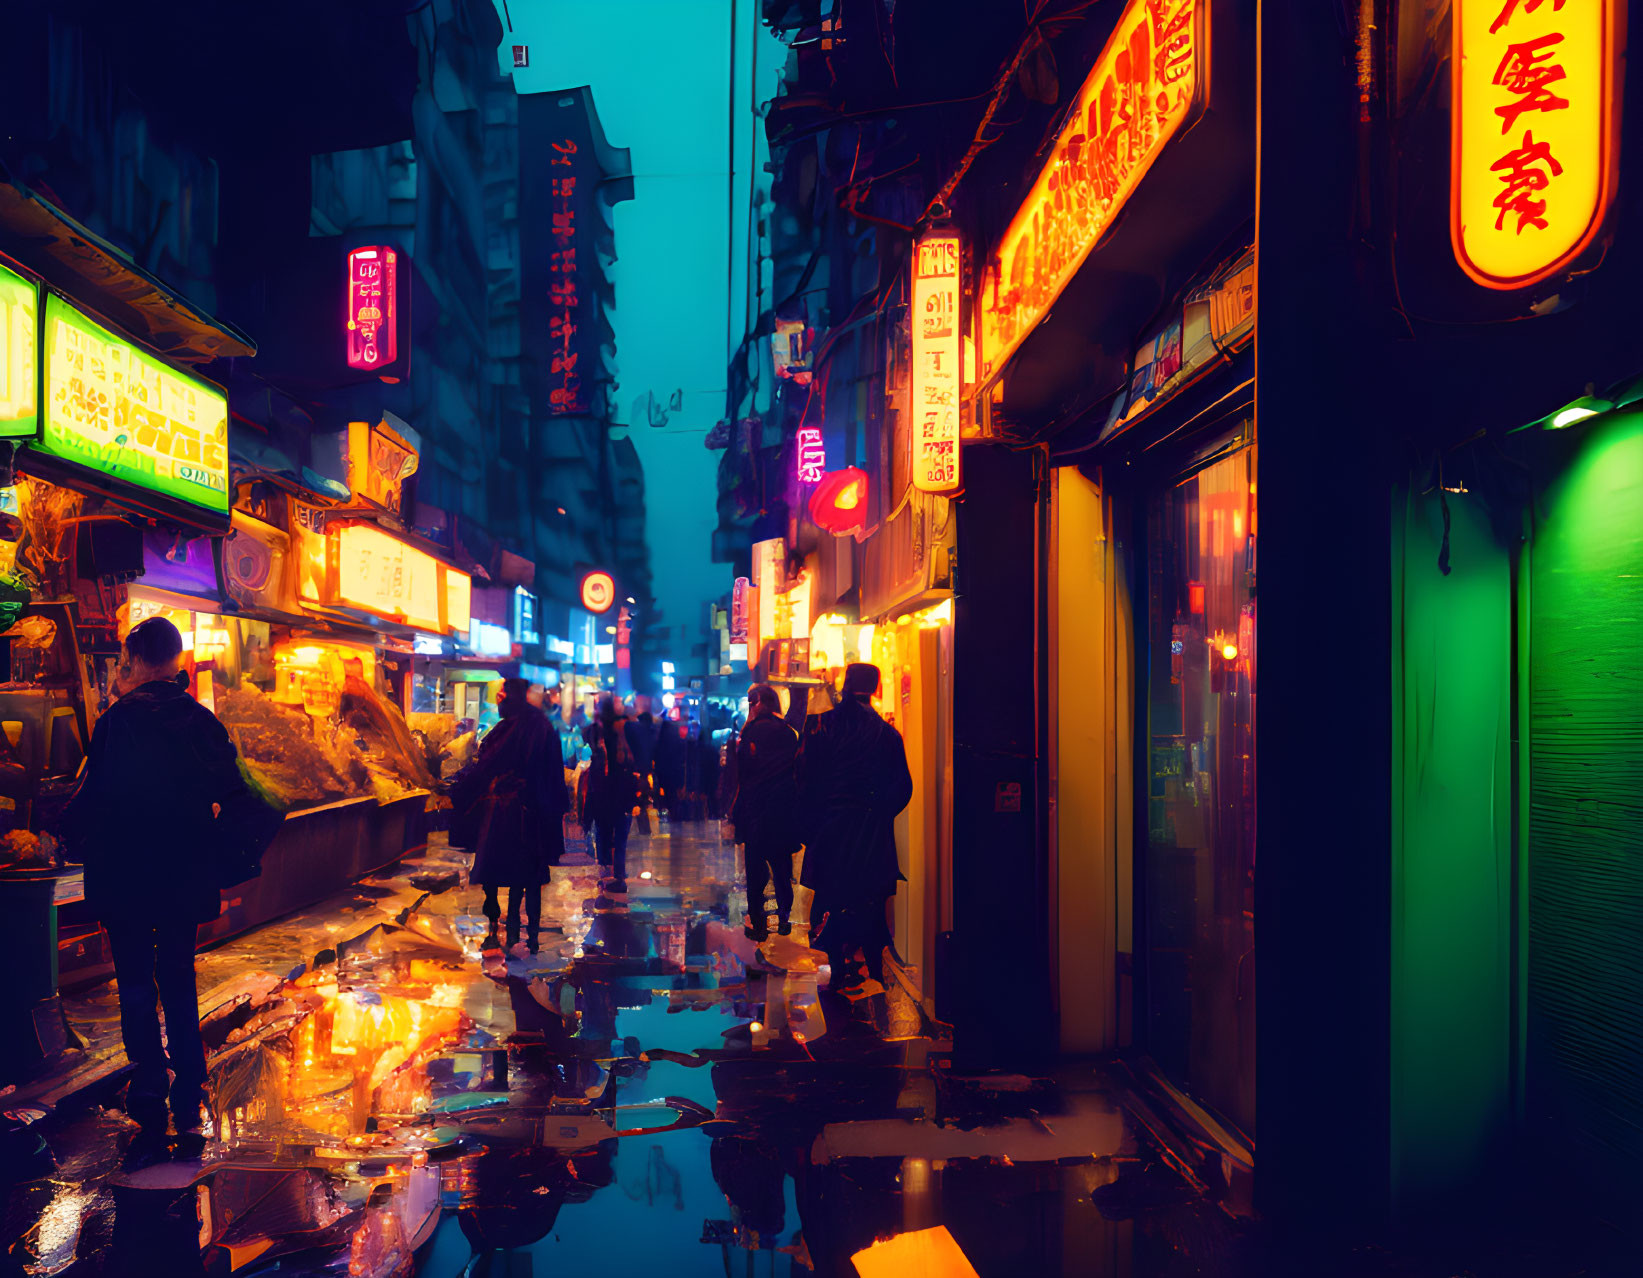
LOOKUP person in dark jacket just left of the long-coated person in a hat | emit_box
[731,683,798,941]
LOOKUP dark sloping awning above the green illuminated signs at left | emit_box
[0,171,256,363]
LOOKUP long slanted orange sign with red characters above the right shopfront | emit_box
[981,0,1209,378]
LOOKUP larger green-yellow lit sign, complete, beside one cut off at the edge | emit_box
[38,294,228,514]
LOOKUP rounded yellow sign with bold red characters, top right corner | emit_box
[1449,0,1620,289]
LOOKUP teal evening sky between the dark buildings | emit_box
[496,0,785,657]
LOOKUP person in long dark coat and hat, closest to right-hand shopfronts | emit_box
[800,662,914,987]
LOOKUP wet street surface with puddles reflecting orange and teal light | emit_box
[5,826,1237,1278]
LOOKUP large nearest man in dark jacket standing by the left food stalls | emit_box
[62,616,283,1138]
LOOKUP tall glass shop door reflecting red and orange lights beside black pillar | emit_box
[1140,447,1255,1137]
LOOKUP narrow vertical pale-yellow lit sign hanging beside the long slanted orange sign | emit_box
[912,232,963,493]
